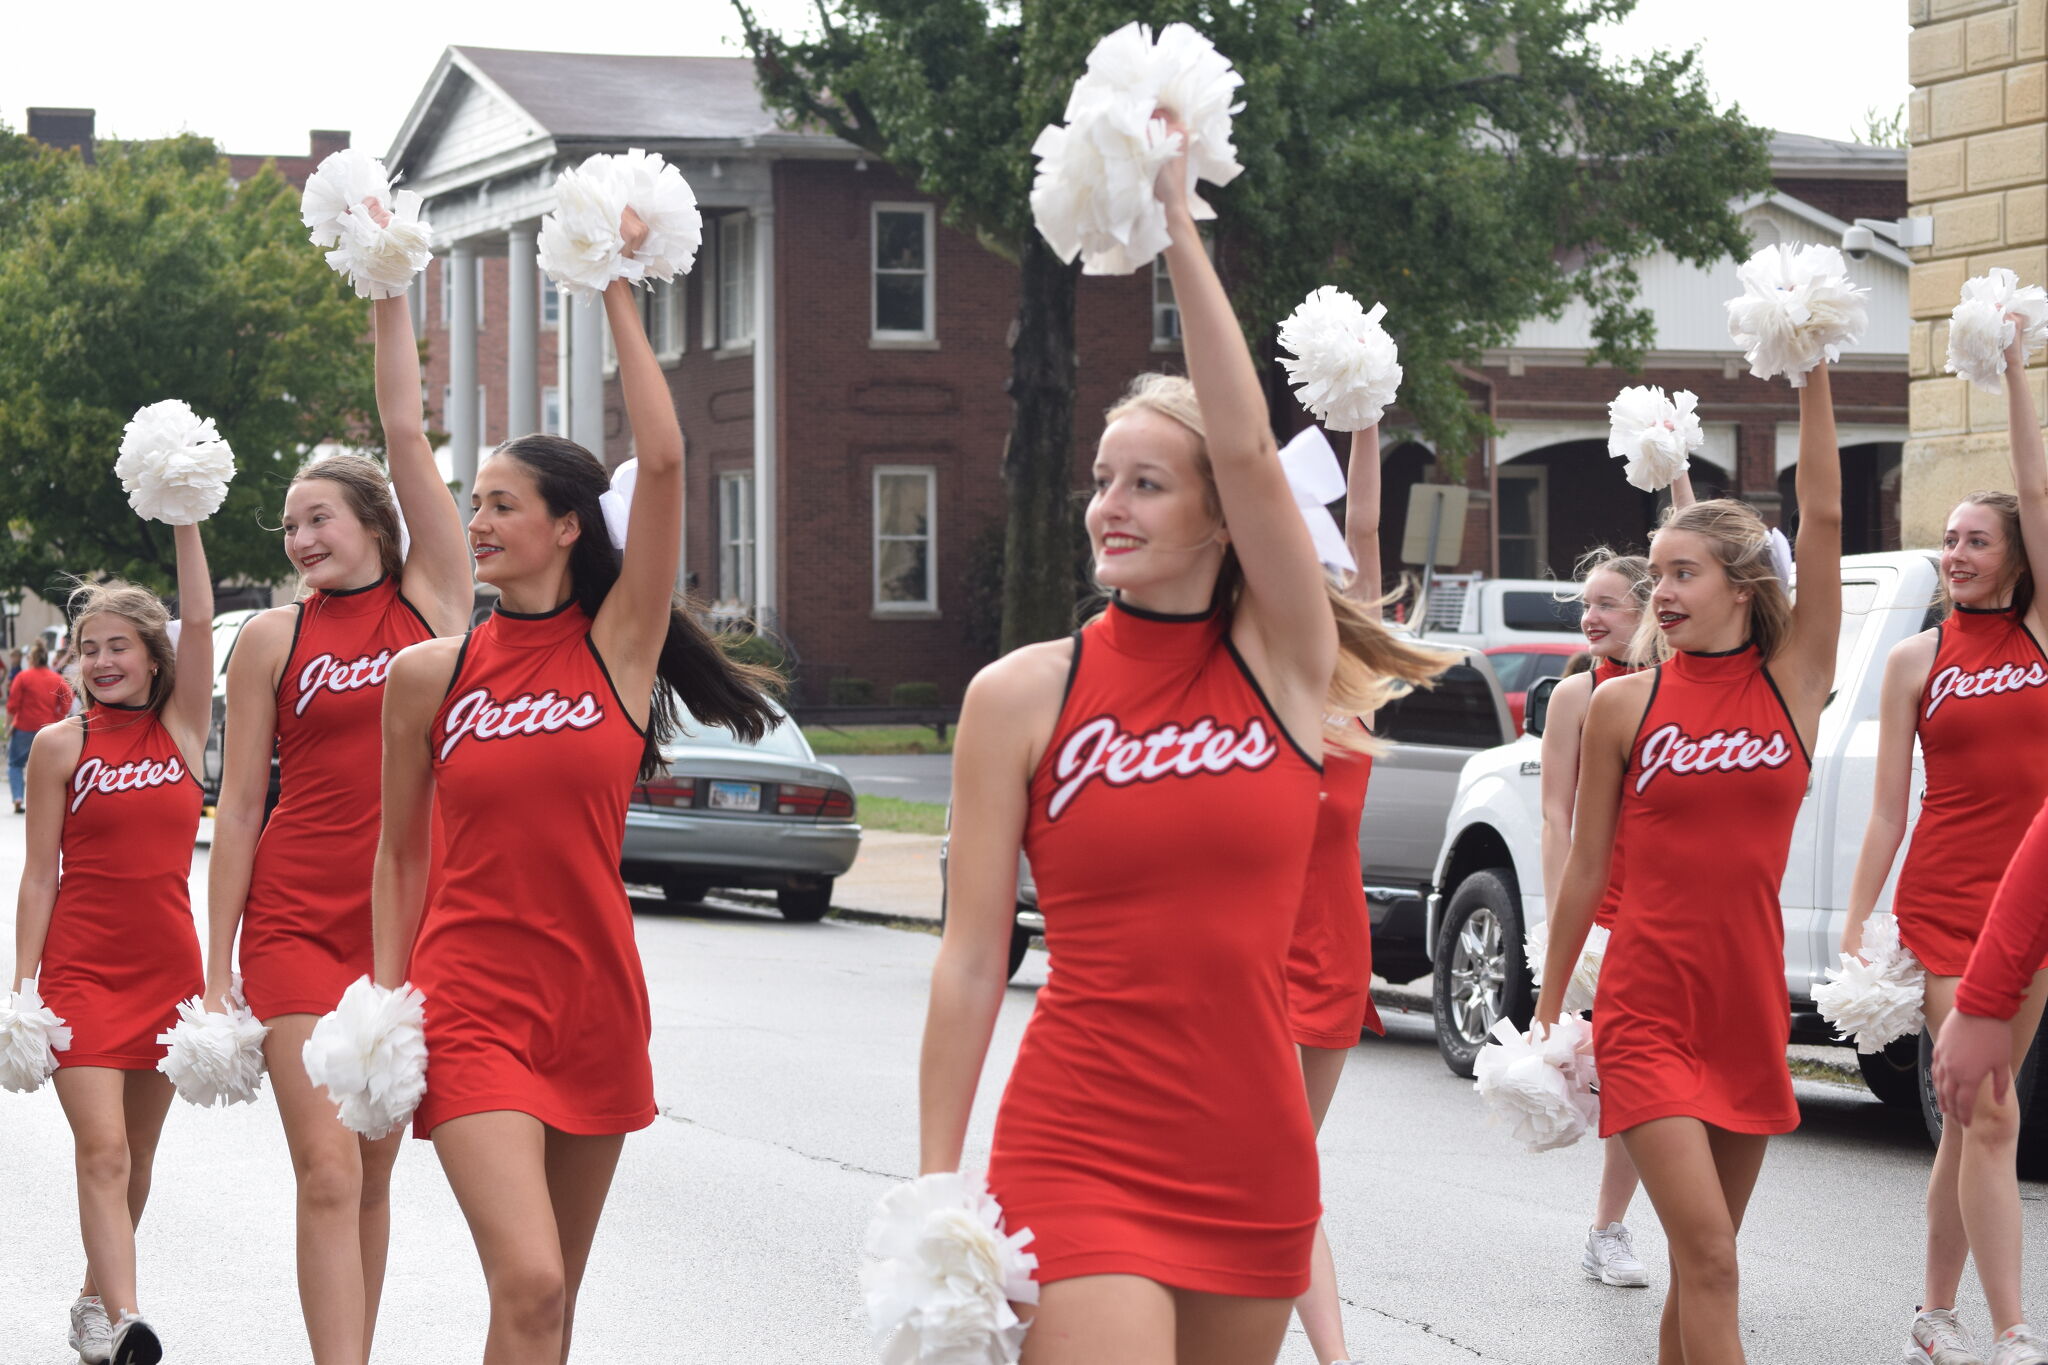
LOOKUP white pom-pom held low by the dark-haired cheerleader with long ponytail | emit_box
[303,976,426,1138]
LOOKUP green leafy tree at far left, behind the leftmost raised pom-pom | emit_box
[0,135,375,600]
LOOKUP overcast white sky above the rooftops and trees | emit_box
[0,0,1909,156]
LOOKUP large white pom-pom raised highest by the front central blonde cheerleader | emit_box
[1030,23,1243,274]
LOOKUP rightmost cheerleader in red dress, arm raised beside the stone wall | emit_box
[1841,325,2048,1365]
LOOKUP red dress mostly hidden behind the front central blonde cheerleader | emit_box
[1286,722,1386,1048]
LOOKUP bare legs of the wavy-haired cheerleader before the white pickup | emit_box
[1622,1117,1767,1365]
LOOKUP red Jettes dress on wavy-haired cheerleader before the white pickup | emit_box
[1593,647,1812,1138]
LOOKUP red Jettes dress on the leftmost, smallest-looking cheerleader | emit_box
[41,702,207,1070]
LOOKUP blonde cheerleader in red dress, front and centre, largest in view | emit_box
[920,133,1337,1365]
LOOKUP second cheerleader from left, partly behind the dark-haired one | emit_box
[207,202,473,1365]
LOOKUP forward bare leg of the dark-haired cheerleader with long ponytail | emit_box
[434,1111,569,1365]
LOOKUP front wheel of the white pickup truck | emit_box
[1430,868,1536,1076]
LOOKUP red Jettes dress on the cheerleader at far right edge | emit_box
[1892,606,2048,976]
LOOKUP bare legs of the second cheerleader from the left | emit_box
[264,1015,406,1365]
